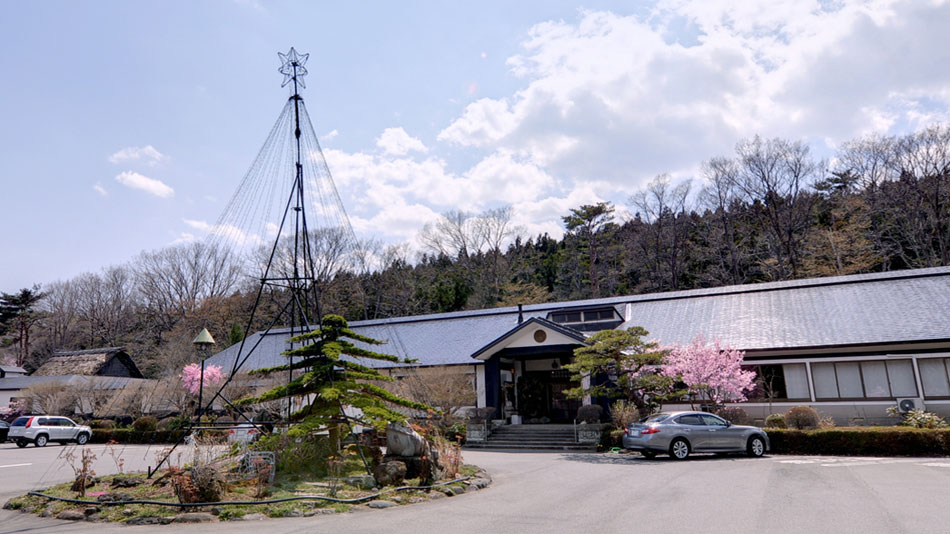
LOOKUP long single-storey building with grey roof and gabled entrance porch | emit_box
[209,267,950,424]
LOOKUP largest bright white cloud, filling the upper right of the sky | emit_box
[438,0,950,187]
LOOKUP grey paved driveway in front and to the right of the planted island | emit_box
[0,451,950,534]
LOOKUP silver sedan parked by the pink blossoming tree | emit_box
[623,412,769,460]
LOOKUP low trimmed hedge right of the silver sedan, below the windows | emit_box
[765,427,950,456]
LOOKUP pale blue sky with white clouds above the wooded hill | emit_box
[0,0,950,292]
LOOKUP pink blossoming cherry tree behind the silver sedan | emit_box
[662,335,755,408]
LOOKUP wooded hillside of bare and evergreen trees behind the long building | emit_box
[0,126,950,376]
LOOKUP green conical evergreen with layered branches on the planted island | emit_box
[241,315,433,427]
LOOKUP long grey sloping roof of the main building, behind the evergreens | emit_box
[209,267,950,370]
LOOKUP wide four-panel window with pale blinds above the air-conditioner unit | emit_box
[811,359,917,400]
